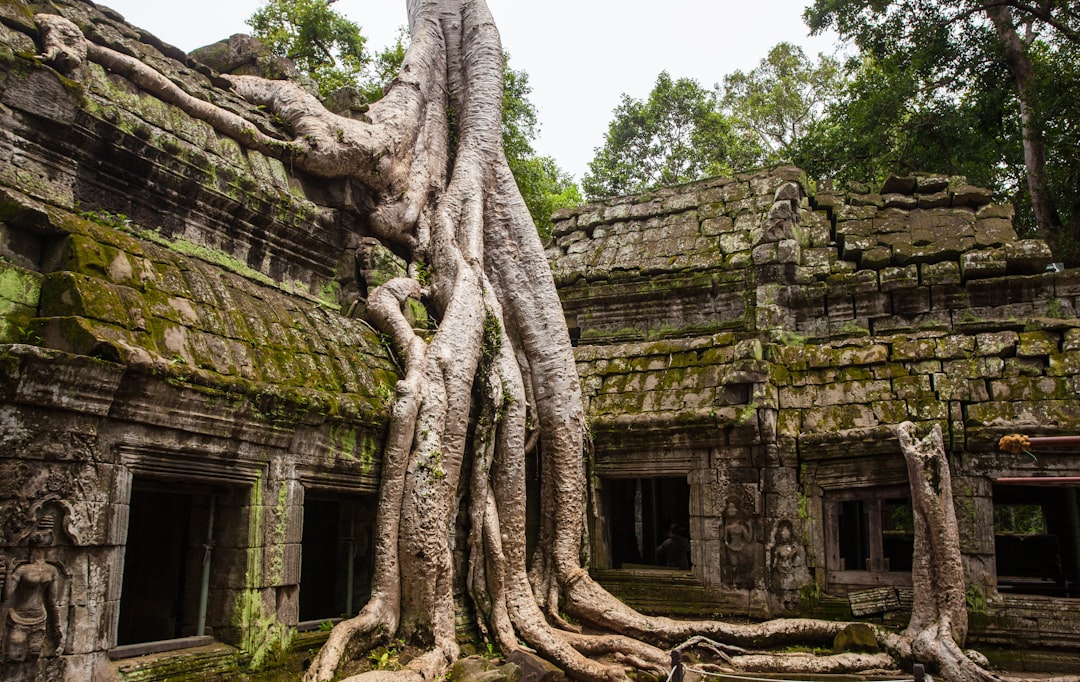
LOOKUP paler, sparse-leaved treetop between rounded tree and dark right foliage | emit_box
[720,42,842,161]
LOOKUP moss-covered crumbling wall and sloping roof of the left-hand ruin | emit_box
[0,0,404,680]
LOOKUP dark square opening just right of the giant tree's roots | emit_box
[603,477,690,569]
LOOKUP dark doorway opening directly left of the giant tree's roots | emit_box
[299,492,375,623]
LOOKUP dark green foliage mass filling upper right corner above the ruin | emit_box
[793,0,1080,253]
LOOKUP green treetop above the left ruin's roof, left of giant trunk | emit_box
[247,0,368,96]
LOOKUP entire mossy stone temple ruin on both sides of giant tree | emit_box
[0,0,1080,680]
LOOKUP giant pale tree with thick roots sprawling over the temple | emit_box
[39,0,1010,680]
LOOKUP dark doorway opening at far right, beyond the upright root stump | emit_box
[994,485,1080,597]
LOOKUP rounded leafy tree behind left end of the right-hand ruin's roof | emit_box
[582,71,764,199]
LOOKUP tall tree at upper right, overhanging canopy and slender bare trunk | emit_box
[805,0,1080,239]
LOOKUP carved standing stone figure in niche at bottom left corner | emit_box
[0,518,63,663]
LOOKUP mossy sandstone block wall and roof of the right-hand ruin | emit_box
[549,168,1080,657]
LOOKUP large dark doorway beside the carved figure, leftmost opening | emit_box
[117,479,216,645]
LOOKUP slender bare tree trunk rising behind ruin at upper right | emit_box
[985,4,1062,236]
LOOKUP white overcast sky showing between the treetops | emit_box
[99,0,837,180]
